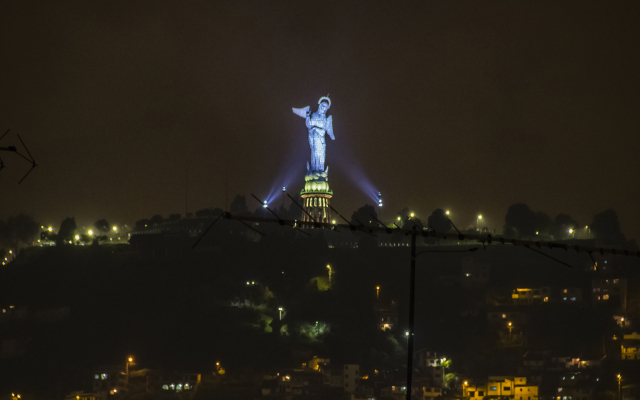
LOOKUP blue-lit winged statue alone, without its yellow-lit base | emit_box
[293,95,336,174]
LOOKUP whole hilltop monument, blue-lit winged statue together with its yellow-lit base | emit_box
[293,96,335,223]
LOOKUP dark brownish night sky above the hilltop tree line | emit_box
[0,0,640,238]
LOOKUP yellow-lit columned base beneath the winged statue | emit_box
[300,168,333,224]
